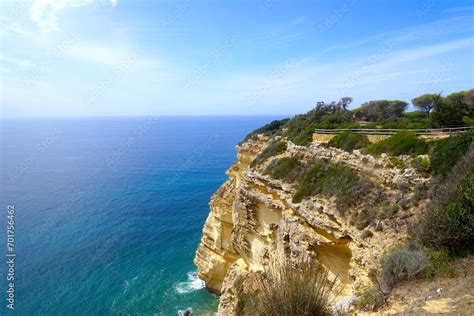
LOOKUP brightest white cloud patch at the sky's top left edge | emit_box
[31,0,118,32]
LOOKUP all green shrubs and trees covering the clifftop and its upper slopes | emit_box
[244,90,474,311]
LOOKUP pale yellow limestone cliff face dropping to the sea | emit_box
[194,137,430,315]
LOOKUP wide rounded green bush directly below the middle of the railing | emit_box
[366,131,428,156]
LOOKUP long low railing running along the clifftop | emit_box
[314,126,474,136]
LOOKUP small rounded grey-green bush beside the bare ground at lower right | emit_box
[381,248,428,289]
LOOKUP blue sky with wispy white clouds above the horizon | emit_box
[0,0,474,117]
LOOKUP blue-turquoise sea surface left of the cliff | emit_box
[0,117,275,315]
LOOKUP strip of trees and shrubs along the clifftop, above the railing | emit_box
[245,89,474,146]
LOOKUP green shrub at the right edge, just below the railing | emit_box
[430,133,474,176]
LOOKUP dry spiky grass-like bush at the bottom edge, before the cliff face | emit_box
[239,260,336,316]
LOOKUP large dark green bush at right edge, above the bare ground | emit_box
[413,148,474,255]
